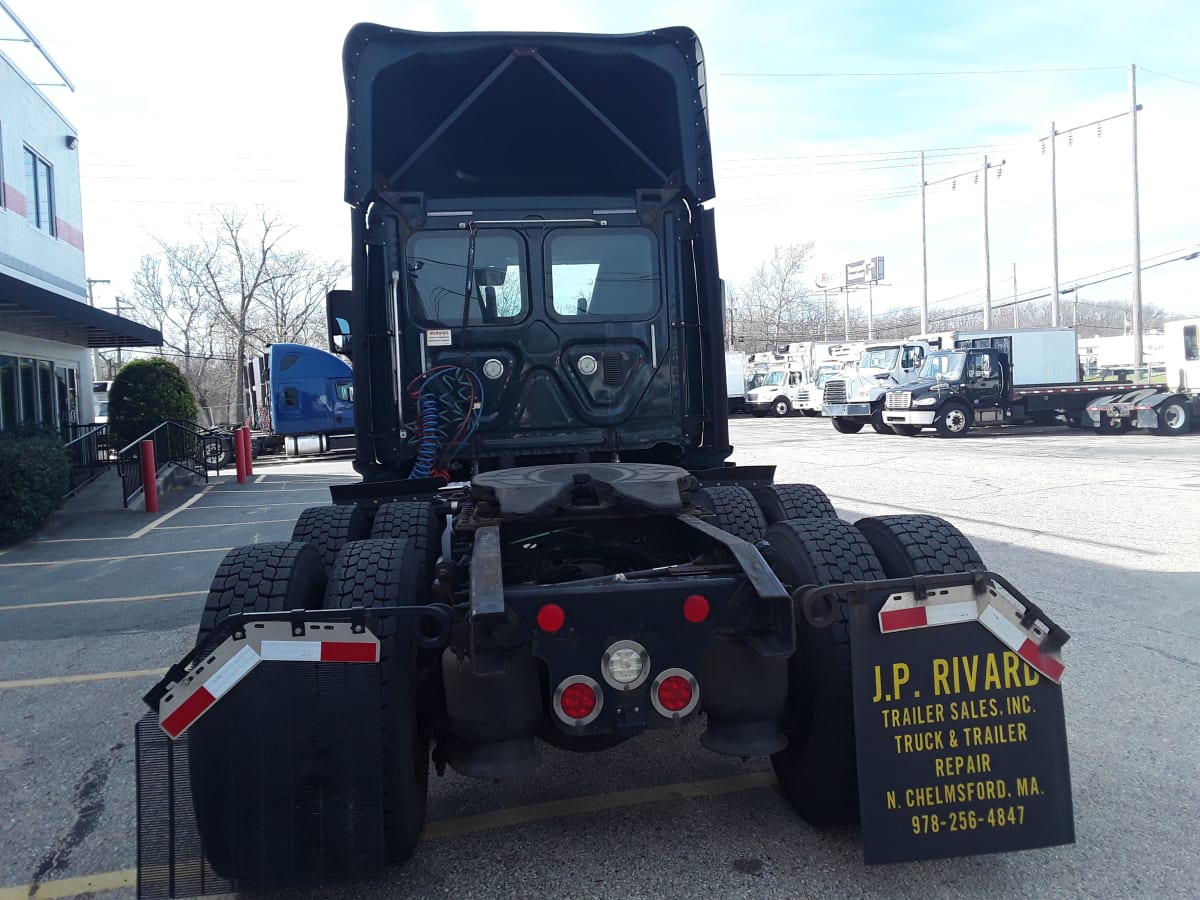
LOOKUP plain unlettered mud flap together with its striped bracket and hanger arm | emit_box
[137,605,450,900]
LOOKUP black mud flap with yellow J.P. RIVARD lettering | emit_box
[850,602,1075,864]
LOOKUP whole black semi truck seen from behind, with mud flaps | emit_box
[138,24,1074,896]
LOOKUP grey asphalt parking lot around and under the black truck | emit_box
[0,418,1200,900]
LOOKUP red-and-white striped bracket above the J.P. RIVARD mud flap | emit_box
[880,580,1064,684]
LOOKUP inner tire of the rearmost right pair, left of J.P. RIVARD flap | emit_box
[766,518,883,828]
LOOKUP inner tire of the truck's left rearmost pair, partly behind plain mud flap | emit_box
[325,539,430,863]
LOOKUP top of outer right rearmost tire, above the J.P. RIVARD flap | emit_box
[854,515,988,578]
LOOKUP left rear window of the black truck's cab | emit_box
[408,232,529,326]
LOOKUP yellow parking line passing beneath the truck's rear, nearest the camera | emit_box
[0,772,775,900]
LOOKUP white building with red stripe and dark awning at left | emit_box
[0,22,162,431]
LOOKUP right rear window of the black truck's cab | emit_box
[546,228,659,318]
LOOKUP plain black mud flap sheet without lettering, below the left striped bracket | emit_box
[137,662,385,900]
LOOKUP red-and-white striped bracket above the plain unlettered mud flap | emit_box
[158,622,379,739]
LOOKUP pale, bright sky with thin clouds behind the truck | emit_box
[9,0,1200,324]
